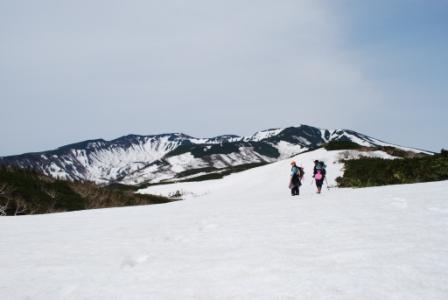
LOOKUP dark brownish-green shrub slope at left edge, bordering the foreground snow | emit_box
[0,167,172,215]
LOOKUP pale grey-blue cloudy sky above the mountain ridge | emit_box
[0,0,448,156]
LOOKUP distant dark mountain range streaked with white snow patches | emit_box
[0,125,428,185]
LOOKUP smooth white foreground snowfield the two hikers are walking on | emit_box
[0,151,448,300]
